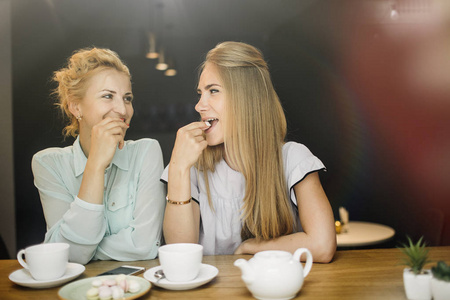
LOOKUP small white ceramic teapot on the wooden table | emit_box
[234,248,312,299]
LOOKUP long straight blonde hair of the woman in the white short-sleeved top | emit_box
[197,42,294,240]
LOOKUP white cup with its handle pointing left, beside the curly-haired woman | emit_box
[17,243,70,281]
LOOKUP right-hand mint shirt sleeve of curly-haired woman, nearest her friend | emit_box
[95,139,166,261]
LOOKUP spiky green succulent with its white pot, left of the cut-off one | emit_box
[400,237,431,300]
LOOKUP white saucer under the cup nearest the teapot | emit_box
[144,264,219,291]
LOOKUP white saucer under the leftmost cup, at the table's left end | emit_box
[9,263,86,289]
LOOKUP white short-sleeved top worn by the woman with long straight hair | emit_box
[161,142,325,255]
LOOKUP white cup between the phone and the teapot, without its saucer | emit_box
[158,243,203,282]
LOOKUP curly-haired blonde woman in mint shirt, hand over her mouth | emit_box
[32,48,165,264]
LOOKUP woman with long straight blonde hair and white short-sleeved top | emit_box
[162,42,336,262]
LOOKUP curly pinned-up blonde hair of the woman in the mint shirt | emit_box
[53,48,131,137]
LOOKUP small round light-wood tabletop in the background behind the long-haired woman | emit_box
[336,221,395,247]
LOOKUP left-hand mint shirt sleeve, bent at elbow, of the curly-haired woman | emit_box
[32,155,106,264]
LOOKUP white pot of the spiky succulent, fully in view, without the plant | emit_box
[403,268,431,300]
